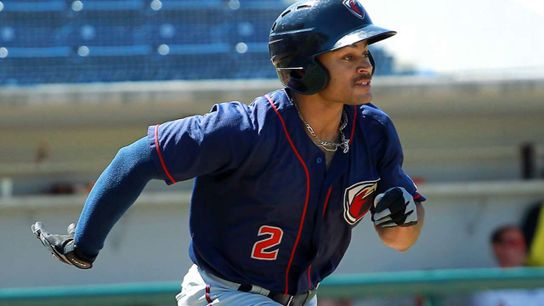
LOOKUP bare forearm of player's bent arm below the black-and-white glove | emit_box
[374,202,425,252]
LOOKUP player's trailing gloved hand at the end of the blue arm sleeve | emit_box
[31,222,94,269]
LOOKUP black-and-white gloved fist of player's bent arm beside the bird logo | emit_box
[371,187,417,227]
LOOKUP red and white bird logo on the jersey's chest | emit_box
[344,180,378,225]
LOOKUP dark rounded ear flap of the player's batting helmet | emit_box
[286,60,329,95]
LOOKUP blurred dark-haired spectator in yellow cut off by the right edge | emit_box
[522,201,544,266]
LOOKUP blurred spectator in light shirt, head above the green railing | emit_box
[473,225,544,306]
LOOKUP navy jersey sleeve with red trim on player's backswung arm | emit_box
[148,102,255,184]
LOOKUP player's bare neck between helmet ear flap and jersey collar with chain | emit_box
[293,94,343,141]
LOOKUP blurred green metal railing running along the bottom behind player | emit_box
[0,268,544,306]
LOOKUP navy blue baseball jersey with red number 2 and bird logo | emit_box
[148,90,424,294]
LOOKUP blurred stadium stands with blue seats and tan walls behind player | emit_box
[0,0,544,305]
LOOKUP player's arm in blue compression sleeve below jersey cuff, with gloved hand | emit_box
[32,138,160,269]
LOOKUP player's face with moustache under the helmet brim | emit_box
[317,41,373,105]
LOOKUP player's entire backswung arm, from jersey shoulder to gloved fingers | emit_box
[32,102,256,269]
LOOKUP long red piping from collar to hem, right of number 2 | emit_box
[265,95,310,294]
